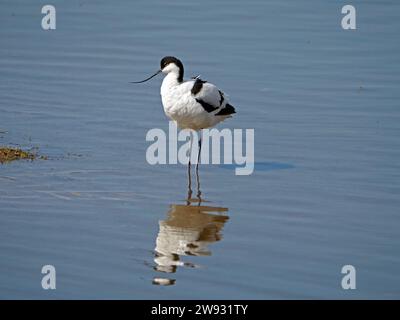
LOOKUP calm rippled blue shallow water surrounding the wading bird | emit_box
[0,0,400,299]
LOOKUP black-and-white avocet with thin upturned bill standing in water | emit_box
[131,56,236,178]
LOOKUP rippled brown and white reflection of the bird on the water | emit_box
[153,169,229,285]
